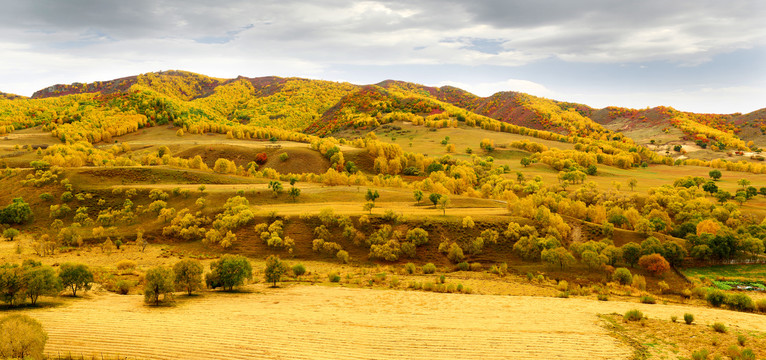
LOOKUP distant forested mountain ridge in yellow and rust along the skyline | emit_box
[0,71,766,147]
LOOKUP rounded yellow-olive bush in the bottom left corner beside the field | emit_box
[0,314,48,360]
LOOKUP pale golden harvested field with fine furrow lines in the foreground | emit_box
[18,285,766,359]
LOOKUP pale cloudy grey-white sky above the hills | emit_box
[0,0,766,113]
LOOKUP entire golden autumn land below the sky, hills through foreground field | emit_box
[0,71,766,359]
